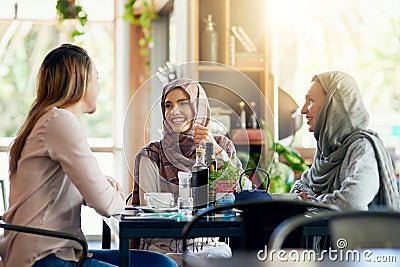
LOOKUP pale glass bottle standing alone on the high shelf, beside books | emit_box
[200,14,218,62]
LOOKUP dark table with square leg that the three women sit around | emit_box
[103,211,243,267]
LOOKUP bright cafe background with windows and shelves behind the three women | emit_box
[0,0,400,266]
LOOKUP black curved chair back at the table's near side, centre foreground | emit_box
[182,200,338,262]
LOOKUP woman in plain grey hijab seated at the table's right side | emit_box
[291,71,399,210]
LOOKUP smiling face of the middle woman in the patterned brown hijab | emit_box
[164,88,194,133]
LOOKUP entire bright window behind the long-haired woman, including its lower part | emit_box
[0,0,123,239]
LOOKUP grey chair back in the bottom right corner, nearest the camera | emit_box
[268,211,400,250]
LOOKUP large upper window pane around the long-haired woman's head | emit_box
[0,21,114,139]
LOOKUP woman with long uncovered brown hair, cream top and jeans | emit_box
[0,44,175,267]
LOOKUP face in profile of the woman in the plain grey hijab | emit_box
[301,80,326,132]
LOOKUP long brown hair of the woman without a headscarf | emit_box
[9,44,93,178]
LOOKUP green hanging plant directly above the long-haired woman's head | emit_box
[56,0,87,39]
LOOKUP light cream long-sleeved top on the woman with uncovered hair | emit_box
[0,109,125,267]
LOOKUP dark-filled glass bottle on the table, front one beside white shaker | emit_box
[191,147,208,208]
